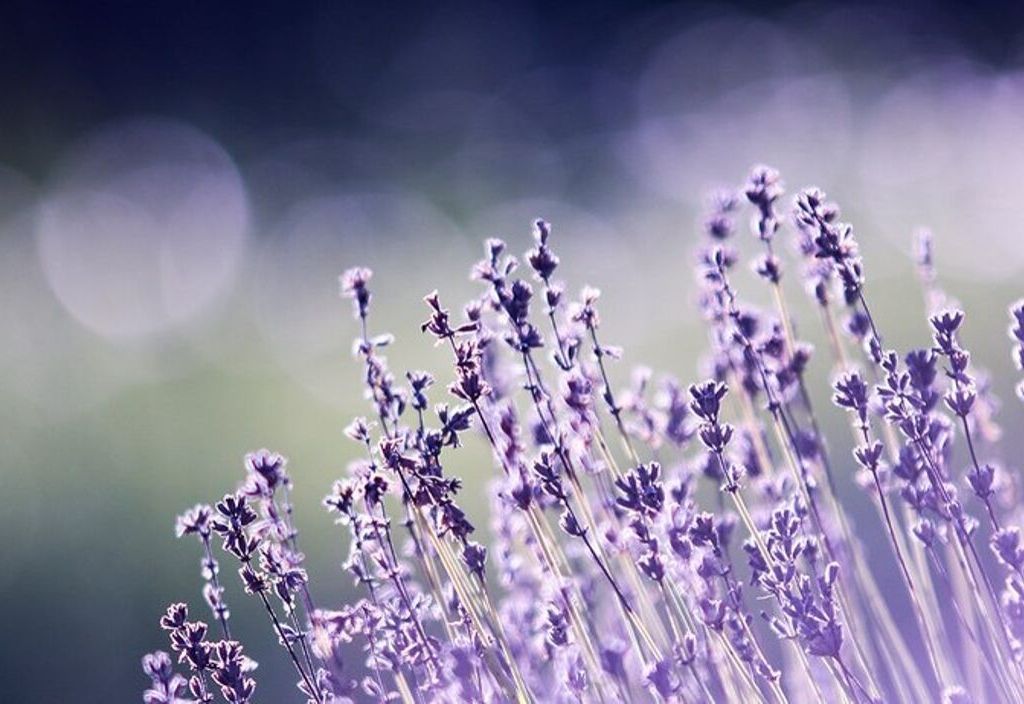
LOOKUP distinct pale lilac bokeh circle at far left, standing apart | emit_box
[37,120,249,340]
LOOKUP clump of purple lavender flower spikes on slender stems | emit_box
[143,167,1024,704]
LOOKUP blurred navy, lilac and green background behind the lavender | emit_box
[6,0,1024,702]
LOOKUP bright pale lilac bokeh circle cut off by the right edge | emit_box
[858,63,1024,277]
